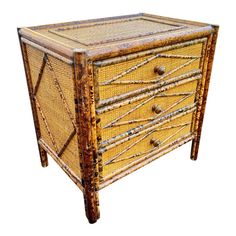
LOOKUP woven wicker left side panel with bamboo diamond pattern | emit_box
[27,46,81,177]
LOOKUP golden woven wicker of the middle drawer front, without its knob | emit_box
[100,80,197,141]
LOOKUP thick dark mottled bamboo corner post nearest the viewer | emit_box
[74,50,100,223]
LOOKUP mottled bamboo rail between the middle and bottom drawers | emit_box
[98,104,196,154]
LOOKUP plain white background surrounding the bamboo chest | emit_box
[0,0,236,236]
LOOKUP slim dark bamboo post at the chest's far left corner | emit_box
[18,29,48,167]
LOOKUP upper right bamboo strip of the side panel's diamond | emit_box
[46,57,76,128]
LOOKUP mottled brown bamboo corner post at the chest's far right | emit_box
[191,26,219,161]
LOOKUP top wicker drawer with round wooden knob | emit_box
[95,40,205,105]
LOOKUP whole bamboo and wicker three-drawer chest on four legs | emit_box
[18,13,218,223]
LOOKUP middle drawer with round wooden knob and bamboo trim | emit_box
[97,74,201,143]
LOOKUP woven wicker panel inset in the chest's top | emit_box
[50,18,180,46]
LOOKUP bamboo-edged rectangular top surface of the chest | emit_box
[18,13,214,60]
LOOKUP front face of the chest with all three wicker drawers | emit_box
[94,38,207,180]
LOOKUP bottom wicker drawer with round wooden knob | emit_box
[102,112,193,178]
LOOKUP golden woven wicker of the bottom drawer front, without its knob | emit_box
[102,113,192,177]
